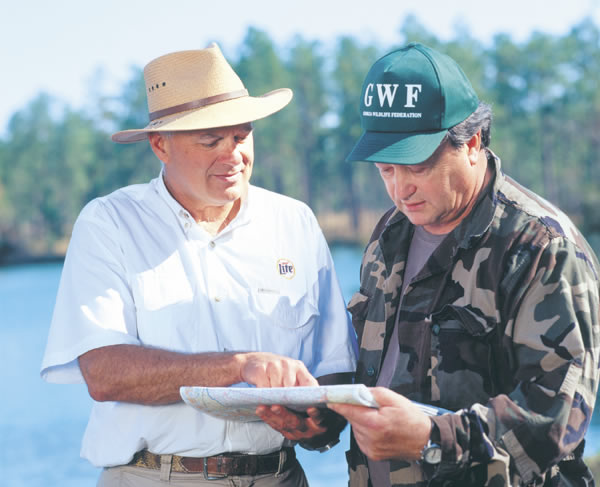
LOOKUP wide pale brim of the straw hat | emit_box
[111,88,293,144]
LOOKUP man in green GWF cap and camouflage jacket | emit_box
[331,44,600,487]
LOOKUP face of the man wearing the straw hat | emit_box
[151,123,254,212]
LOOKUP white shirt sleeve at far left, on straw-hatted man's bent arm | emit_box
[41,200,139,383]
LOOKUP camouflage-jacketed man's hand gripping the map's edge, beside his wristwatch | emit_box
[328,387,431,460]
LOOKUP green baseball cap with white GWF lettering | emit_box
[346,42,479,164]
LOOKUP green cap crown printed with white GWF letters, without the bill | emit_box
[360,43,479,133]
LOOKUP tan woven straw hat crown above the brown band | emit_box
[144,45,245,113]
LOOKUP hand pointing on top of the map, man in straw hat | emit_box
[240,352,319,387]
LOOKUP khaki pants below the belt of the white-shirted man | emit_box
[97,460,308,487]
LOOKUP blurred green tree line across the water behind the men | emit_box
[0,17,600,263]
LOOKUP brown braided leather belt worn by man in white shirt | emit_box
[128,448,296,478]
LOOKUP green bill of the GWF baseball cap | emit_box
[346,129,448,165]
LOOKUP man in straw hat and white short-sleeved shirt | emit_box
[42,45,356,486]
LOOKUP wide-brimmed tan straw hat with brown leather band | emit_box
[112,43,292,144]
